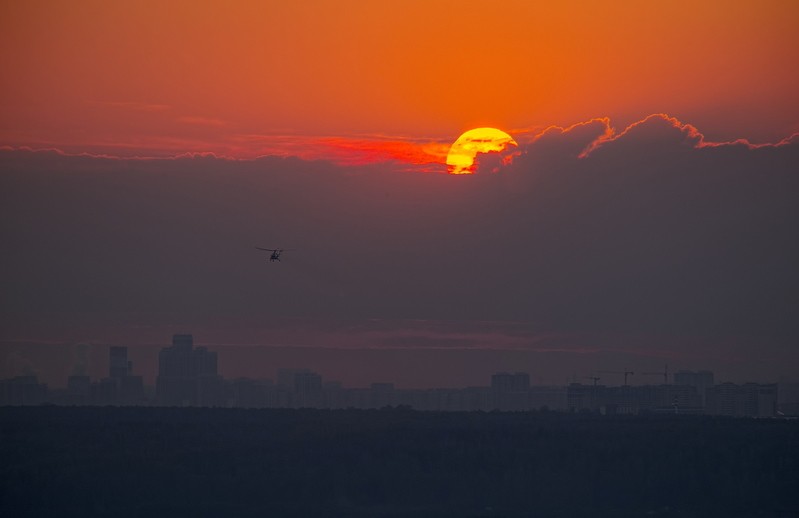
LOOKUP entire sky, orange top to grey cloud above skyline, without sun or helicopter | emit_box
[0,1,799,385]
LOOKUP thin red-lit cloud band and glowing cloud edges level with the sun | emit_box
[5,114,799,173]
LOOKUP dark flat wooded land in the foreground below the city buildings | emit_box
[0,407,799,517]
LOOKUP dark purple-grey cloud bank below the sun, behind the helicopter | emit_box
[0,119,799,384]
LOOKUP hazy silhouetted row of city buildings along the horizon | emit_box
[0,334,799,417]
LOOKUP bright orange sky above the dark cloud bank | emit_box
[0,0,799,162]
